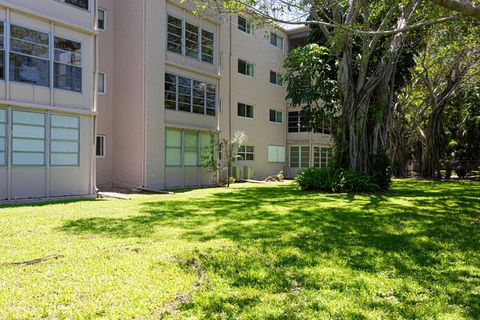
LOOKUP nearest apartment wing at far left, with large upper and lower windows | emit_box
[0,0,96,200]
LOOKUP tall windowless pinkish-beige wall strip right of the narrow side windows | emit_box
[110,0,145,187]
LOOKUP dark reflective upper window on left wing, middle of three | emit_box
[10,25,50,87]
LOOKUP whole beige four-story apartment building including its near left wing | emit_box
[0,0,330,199]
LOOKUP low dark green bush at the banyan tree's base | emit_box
[295,167,381,193]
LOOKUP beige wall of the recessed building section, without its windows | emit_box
[97,0,334,189]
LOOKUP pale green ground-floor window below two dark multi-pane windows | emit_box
[165,129,213,167]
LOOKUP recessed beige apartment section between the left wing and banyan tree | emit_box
[93,0,330,189]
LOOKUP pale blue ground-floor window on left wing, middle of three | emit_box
[12,111,45,166]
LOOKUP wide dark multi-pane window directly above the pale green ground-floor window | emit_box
[165,73,217,116]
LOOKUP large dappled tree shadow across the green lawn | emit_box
[62,182,480,318]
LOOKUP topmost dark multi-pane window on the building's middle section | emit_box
[167,16,215,63]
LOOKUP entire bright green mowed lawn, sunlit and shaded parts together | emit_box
[0,180,480,319]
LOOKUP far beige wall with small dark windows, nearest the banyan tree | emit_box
[220,16,287,179]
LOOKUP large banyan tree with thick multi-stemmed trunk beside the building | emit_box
[190,0,475,178]
